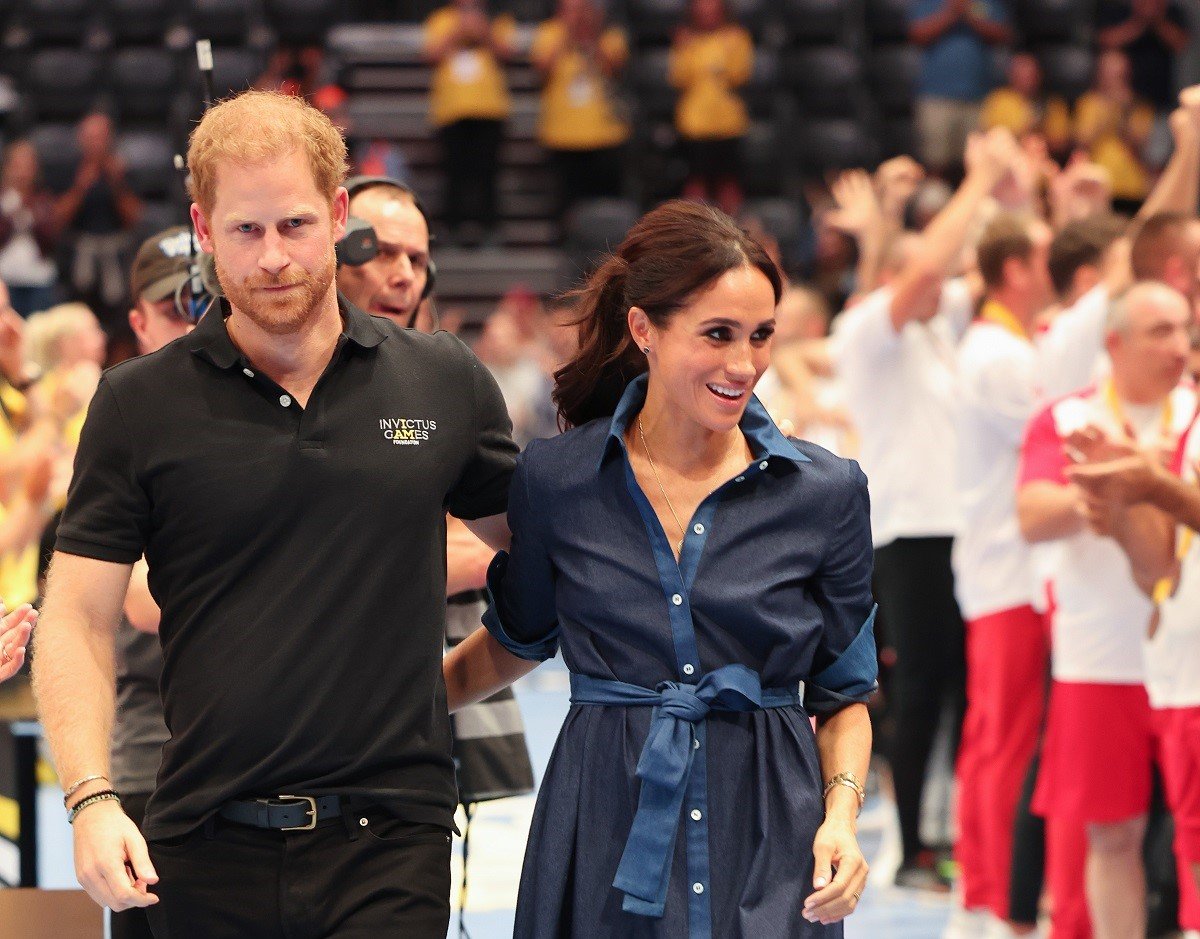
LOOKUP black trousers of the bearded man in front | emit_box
[148,807,450,939]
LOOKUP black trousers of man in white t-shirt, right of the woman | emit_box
[875,538,966,862]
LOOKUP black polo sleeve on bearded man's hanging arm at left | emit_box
[55,377,150,564]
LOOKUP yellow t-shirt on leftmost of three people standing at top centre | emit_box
[425,6,516,127]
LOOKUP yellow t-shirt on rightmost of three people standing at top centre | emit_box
[671,26,754,140]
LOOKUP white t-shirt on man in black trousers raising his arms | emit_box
[830,280,973,548]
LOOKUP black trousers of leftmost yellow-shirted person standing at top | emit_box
[439,120,504,232]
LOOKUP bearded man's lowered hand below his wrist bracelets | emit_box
[74,799,158,913]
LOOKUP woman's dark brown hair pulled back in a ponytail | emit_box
[554,199,784,429]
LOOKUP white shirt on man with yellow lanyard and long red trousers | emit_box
[952,305,1037,620]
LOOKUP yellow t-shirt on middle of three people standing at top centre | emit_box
[529,19,629,150]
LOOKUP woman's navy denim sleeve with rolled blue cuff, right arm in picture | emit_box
[804,460,878,714]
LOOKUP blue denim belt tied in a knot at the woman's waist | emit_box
[571,665,800,917]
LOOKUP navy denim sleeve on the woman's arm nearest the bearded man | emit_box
[484,441,558,662]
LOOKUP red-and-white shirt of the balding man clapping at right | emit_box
[1019,385,1196,684]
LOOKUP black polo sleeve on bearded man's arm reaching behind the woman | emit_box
[446,337,517,521]
